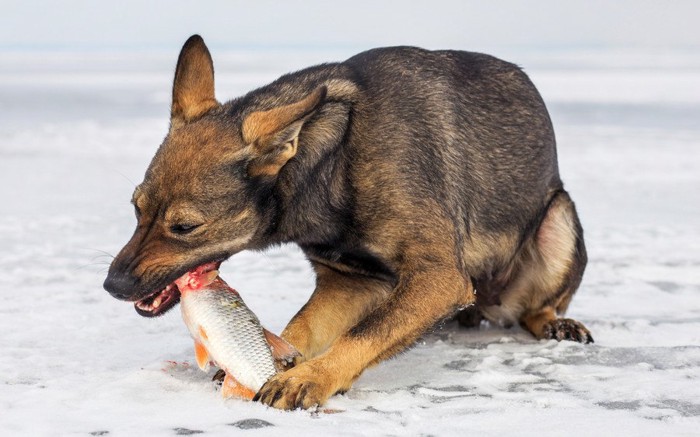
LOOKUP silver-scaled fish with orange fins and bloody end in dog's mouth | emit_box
[175,263,300,400]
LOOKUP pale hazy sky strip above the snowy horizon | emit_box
[0,0,700,49]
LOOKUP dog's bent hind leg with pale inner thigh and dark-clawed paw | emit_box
[484,191,593,343]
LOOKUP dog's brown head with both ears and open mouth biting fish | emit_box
[104,35,326,317]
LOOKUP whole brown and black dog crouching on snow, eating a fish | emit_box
[104,35,592,409]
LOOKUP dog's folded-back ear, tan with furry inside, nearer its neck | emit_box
[241,86,327,176]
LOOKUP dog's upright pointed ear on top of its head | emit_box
[170,35,219,122]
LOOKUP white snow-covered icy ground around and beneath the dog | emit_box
[0,46,700,436]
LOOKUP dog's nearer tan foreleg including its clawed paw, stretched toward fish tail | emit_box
[256,246,474,409]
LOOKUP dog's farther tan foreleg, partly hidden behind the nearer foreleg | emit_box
[282,263,391,364]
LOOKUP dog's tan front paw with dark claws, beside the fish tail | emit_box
[253,362,337,410]
